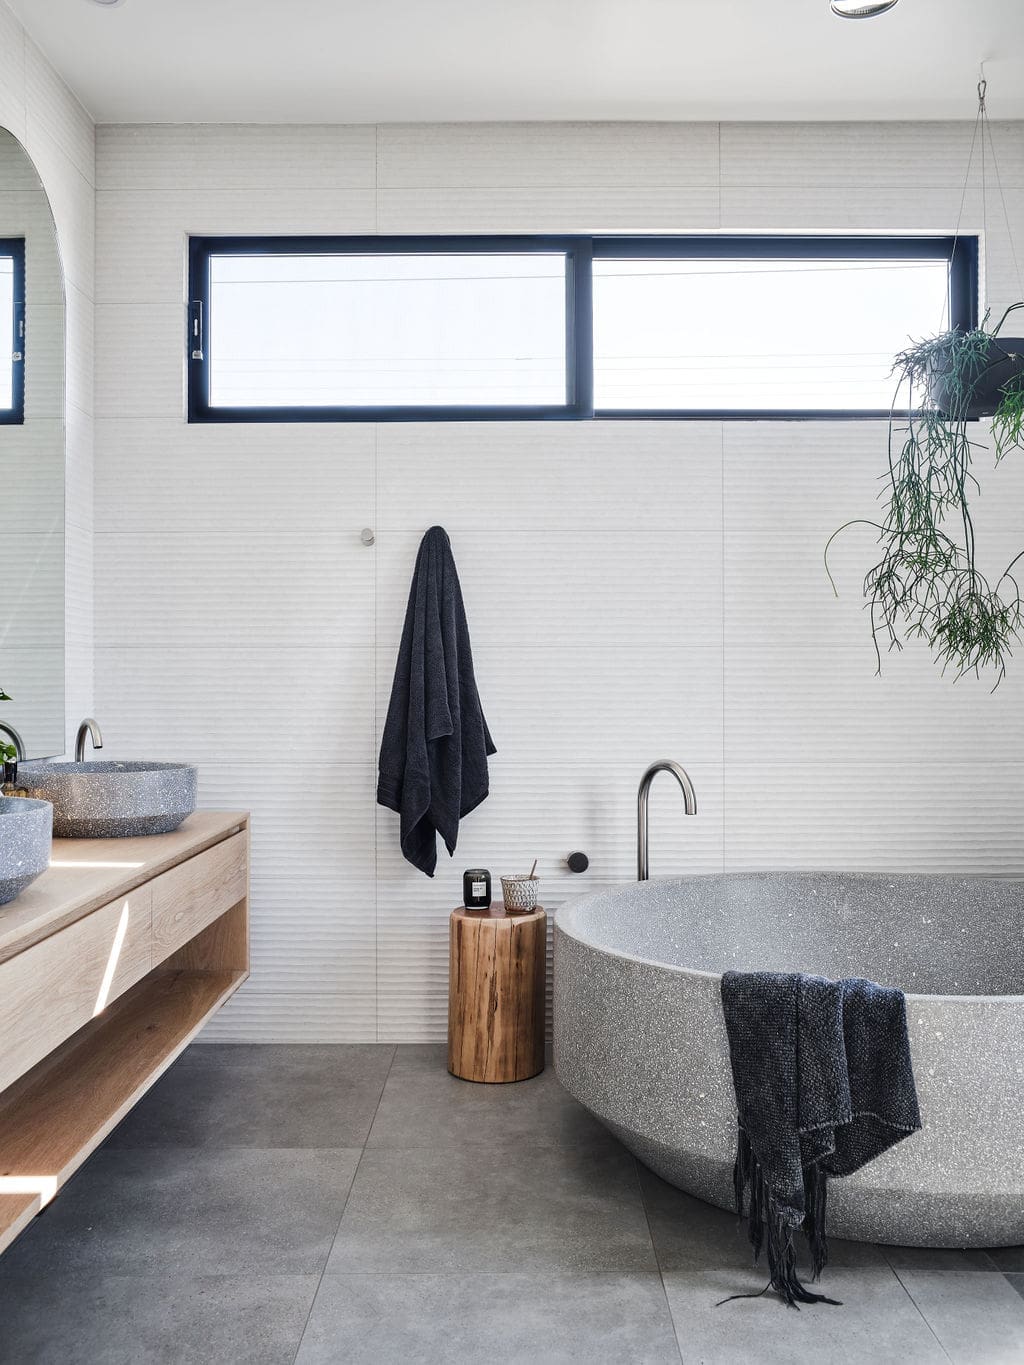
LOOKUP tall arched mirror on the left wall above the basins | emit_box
[0,128,64,758]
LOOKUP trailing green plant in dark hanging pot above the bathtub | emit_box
[825,303,1024,687]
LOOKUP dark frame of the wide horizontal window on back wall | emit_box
[186,233,979,422]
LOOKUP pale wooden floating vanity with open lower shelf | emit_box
[0,811,248,1250]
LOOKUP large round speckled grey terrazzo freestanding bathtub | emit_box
[554,872,1024,1246]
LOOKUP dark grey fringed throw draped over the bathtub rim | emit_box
[722,972,920,1306]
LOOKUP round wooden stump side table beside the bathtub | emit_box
[448,905,547,1082]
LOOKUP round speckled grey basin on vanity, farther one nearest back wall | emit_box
[18,762,197,839]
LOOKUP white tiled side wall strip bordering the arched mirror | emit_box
[0,0,96,747]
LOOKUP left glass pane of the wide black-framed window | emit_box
[209,253,565,407]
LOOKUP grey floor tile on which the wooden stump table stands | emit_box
[367,1046,614,1148]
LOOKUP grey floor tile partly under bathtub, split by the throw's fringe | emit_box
[640,1166,886,1276]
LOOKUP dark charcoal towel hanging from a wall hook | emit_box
[377,526,496,876]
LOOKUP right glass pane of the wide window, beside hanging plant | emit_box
[594,258,949,411]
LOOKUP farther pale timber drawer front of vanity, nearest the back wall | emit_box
[150,834,248,962]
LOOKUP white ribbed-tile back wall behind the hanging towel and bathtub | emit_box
[96,124,1024,1041]
